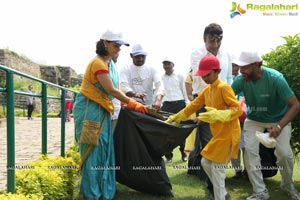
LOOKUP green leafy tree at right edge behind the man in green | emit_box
[262,34,300,155]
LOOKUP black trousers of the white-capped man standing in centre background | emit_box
[161,100,186,159]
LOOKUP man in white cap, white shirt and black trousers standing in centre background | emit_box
[161,57,188,163]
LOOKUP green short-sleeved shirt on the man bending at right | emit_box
[231,67,295,123]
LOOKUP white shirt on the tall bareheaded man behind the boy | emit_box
[191,46,233,95]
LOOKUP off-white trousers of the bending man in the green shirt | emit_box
[244,119,294,193]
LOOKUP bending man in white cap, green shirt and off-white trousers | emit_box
[232,51,300,200]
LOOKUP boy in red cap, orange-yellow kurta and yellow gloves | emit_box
[167,55,242,200]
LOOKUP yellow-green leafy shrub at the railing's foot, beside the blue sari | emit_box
[16,155,78,200]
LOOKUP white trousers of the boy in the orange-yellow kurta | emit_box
[201,157,227,200]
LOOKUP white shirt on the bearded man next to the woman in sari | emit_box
[120,63,165,106]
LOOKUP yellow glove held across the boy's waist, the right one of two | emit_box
[198,107,231,123]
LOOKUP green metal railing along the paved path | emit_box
[0,65,76,193]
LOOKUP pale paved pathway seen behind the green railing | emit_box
[0,117,74,190]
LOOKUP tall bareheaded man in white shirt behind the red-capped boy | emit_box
[188,23,233,199]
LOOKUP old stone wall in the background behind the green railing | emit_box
[0,49,82,113]
